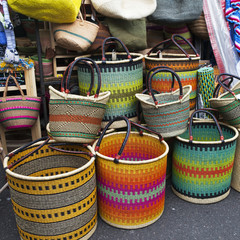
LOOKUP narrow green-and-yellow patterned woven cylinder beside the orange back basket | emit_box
[197,67,215,108]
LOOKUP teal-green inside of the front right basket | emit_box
[179,122,236,142]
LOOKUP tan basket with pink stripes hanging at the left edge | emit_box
[0,75,41,130]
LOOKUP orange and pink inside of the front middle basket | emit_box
[99,132,166,161]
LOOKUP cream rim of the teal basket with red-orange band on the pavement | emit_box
[176,119,239,145]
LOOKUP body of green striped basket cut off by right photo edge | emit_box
[209,85,240,128]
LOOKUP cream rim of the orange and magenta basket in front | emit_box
[92,131,169,165]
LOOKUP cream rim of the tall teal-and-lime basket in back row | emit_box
[75,52,144,64]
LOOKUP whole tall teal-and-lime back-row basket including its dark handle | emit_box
[78,37,143,128]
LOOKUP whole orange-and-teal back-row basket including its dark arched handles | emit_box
[145,34,200,110]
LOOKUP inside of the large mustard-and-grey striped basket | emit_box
[8,144,91,177]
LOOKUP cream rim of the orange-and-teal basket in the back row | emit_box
[144,52,200,62]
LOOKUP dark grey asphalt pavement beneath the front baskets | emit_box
[0,156,240,240]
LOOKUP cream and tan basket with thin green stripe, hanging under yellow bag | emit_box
[53,13,99,52]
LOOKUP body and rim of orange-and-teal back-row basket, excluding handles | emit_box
[145,54,200,110]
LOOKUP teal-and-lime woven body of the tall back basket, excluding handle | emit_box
[78,54,143,128]
